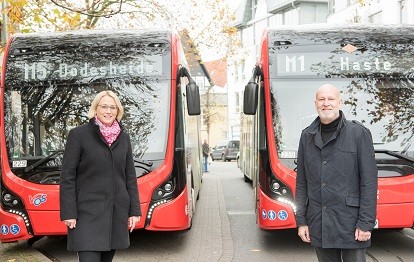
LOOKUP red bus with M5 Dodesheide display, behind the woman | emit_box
[0,30,202,242]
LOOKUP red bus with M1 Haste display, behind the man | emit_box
[240,25,414,230]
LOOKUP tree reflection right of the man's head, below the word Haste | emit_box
[343,78,414,145]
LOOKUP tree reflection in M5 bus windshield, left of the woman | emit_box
[5,85,88,156]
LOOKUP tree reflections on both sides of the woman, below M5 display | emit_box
[5,79,168,160]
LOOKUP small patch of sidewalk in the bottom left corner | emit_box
[0,241,51,262]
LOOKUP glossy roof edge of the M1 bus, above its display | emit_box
[265,24,414,47]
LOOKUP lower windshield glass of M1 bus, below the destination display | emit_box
[271,78,414,158]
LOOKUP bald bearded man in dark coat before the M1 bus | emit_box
[296,84,378,262]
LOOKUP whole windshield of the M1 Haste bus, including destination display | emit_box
[269,40,414,159]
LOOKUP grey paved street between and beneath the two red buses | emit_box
[4,161,414,262]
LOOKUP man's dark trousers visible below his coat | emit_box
[315,247,366,262]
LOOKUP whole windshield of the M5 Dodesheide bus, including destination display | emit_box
[4,33,171,171]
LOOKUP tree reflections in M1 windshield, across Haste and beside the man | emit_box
[298,41,414,145]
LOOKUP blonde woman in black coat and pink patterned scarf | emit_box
[60,91,141,262]
